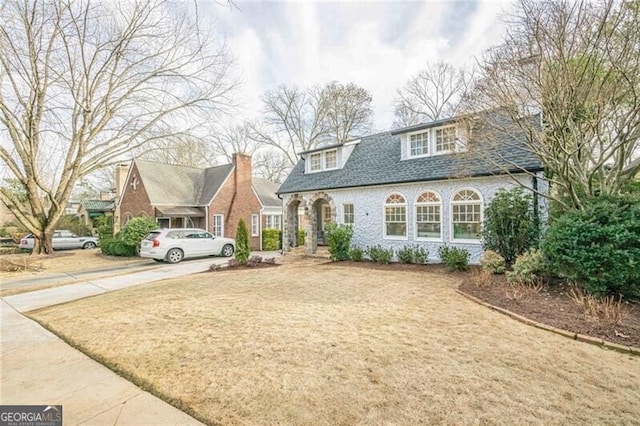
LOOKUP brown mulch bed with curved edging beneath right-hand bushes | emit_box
[459,276,640,348]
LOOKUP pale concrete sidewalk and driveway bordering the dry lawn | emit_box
[0,253,278,425]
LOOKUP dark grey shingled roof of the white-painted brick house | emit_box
[278,125,542,194]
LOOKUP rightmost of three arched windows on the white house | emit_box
[451,189,482,240]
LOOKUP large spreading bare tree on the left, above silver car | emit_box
[0,0,235,253]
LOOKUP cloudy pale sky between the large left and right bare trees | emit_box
[208,0,510,130]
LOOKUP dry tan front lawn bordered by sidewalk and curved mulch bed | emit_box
[28,260,640,425]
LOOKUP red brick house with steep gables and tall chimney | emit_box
[115,154,282,250]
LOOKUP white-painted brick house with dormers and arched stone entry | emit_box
[278,112,548,263]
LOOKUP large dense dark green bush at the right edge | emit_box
[541,196,640,298]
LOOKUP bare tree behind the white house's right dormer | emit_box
[394,62,473,127]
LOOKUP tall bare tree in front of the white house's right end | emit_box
[467,0,640,208]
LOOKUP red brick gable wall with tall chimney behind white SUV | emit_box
[209,154,260,250]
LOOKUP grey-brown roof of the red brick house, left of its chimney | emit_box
[135,160,233,206]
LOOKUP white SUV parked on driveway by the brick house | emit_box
[140,228,236,263]
